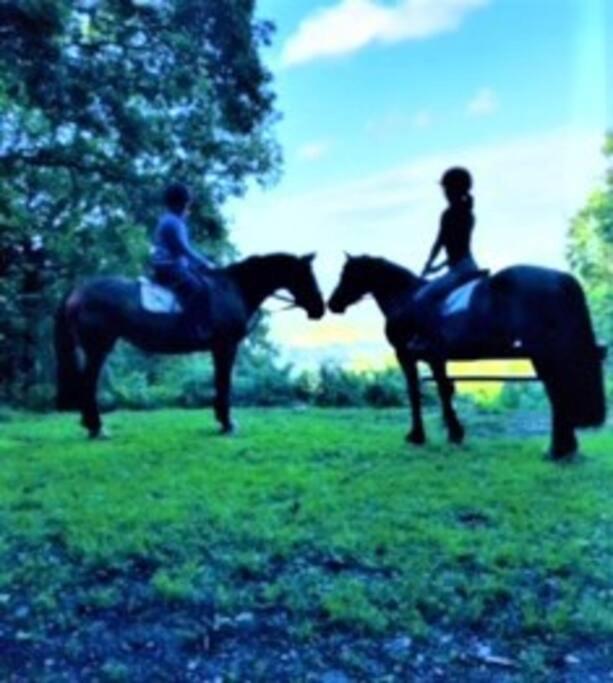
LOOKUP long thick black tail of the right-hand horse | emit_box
[559,278,606,427]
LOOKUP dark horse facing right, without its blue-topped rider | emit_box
[55,254,325,438]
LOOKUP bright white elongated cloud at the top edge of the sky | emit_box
[281,0,489,66]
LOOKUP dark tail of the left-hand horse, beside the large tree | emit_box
[54,298,81,411]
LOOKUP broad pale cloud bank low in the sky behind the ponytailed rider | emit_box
[227,128,605,366]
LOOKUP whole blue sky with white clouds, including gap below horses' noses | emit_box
[226,0,613,365]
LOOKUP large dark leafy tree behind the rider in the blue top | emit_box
[0,0,278,399]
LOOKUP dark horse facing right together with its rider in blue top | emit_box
[55,183,325,438]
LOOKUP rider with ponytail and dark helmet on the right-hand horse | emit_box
[410,167,479,351]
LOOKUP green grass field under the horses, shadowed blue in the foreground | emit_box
[0,409,613,683]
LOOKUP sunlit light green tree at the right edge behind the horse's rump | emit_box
[567,133,613,346]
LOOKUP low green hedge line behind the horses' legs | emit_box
[13,345,556,412]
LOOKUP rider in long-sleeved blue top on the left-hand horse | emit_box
[151,182,215,339]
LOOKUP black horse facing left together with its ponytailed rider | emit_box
[328,168,605,458]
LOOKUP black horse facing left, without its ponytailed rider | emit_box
[328,256,605,458]
